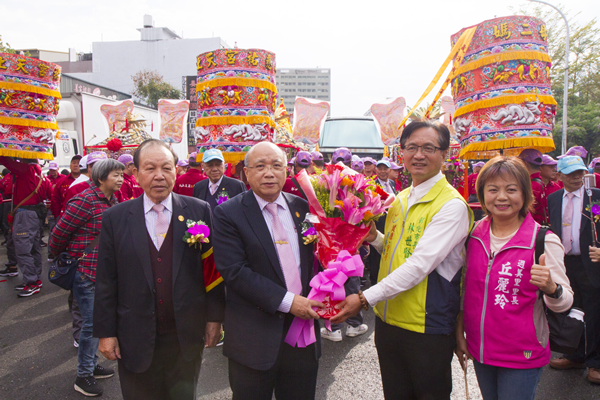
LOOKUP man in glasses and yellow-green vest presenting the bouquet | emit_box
[331,121,473,399]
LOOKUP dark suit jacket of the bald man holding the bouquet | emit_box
[213,190,321,370]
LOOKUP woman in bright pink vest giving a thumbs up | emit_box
[456,156,573,400]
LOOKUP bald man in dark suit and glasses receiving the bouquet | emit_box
[213,143,323,400]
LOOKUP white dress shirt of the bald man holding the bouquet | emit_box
[253,192,302,313]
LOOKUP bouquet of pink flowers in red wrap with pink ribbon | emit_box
[285,163,395,347]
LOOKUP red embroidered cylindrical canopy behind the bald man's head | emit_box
[194,49,277,163]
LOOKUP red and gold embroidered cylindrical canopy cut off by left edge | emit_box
[0,53,62,160]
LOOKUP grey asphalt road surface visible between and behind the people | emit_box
[0,233,600,400]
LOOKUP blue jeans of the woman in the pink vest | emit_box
[473,360,542,400]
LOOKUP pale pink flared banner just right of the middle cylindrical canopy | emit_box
[292,97,330,145]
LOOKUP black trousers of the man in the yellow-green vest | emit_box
[375,318,456,400]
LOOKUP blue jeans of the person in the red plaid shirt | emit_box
[73,271,98,377]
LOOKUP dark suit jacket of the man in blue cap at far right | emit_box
[548,189,600,288]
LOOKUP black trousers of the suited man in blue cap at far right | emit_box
[565,255,600,368]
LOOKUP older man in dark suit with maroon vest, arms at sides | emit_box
[94,139,225,400]
